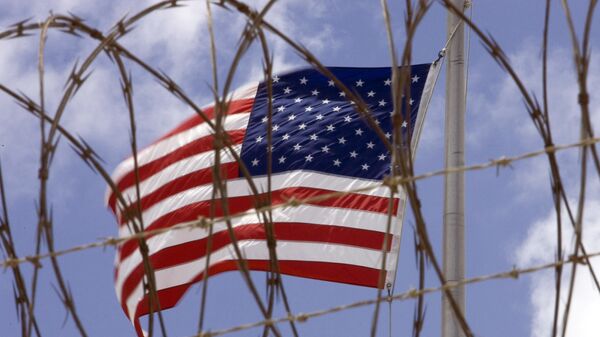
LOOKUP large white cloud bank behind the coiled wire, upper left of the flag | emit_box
[0,0,346,205]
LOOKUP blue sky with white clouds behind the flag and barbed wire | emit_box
[0,0,600,336]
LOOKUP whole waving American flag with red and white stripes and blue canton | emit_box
[107,64,435,332]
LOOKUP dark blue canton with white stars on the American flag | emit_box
[241,64,430,180]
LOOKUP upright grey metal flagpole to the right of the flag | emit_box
[442,0,466,337]
